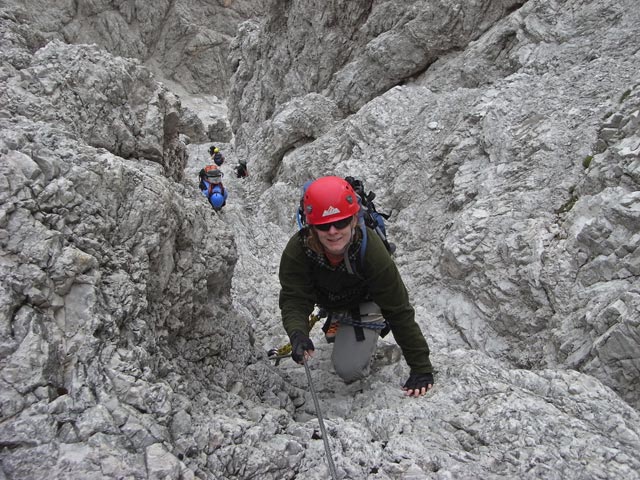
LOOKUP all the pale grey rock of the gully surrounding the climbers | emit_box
[0,0,640,479]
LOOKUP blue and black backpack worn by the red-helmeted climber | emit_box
[296,177,396,261]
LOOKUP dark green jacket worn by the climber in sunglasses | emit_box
[279,228,433,373]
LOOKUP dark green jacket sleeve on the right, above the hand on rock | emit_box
[363,230,433,373]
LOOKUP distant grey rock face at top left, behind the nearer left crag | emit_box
[2,0,268,98]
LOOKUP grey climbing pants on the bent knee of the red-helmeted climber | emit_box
[331,302,384,383]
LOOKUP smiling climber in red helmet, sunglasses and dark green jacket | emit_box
[279,177,434,397]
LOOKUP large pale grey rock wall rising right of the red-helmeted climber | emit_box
[230,1,640,407]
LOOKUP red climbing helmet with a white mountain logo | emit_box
[304,177,360,225]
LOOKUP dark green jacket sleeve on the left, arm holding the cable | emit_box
[278,234,316,337]
